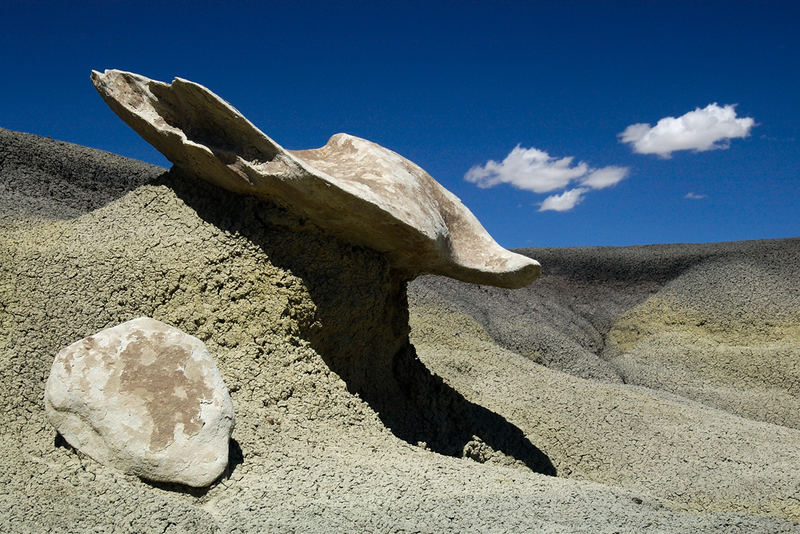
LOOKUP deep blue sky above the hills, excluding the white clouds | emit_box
[0,0,800,248]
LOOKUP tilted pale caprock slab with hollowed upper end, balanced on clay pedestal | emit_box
[92,70,540,288]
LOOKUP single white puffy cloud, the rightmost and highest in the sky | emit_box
[618,102,755,158]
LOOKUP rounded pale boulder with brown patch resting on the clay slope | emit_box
[45,317,234,486]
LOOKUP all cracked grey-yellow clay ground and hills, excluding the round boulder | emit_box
[0,126,800,533]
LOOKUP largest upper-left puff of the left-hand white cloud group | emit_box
[464,145,592,193]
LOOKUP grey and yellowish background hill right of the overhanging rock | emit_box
[410,238,800,429]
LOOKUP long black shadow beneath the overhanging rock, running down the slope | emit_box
[163,170,556,475]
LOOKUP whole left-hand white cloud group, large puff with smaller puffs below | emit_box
[464,145,629,215]
